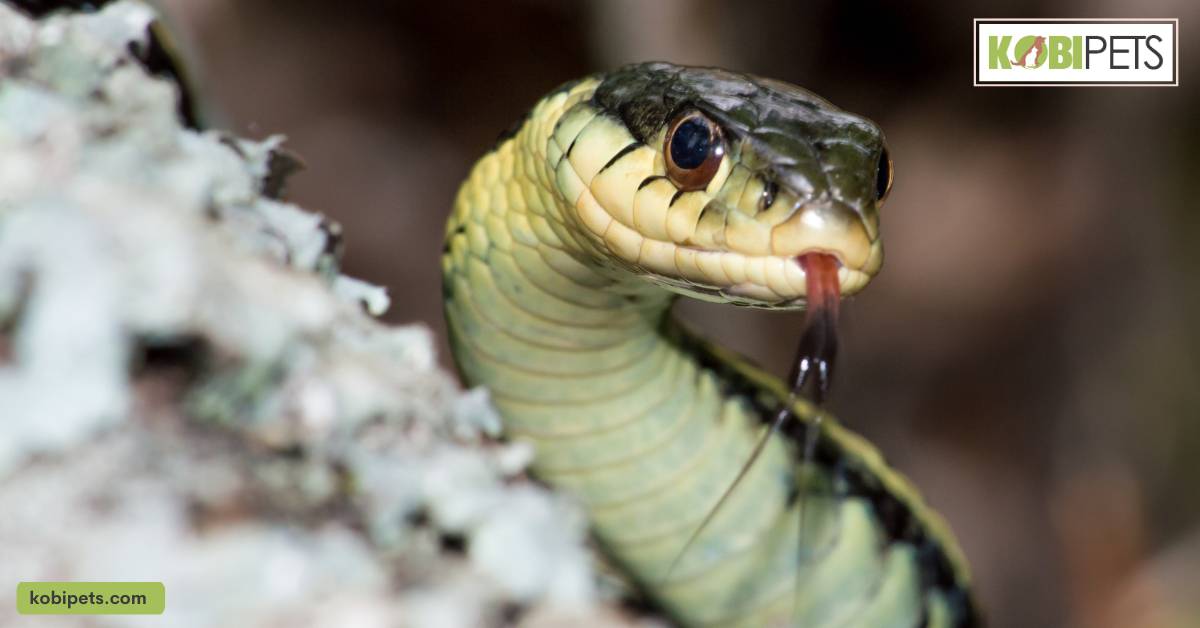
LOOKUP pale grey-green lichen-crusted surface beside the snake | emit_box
[0,1,657,627]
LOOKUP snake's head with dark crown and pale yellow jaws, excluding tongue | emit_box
[547,62,892,309]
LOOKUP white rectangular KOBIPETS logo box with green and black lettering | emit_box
[974,18,1180,85]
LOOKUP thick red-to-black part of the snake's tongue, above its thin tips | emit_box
[791,253,841,405]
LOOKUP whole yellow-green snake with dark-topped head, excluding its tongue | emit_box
[442,64,978,627]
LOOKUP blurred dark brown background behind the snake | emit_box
[154,0,1200,627]
